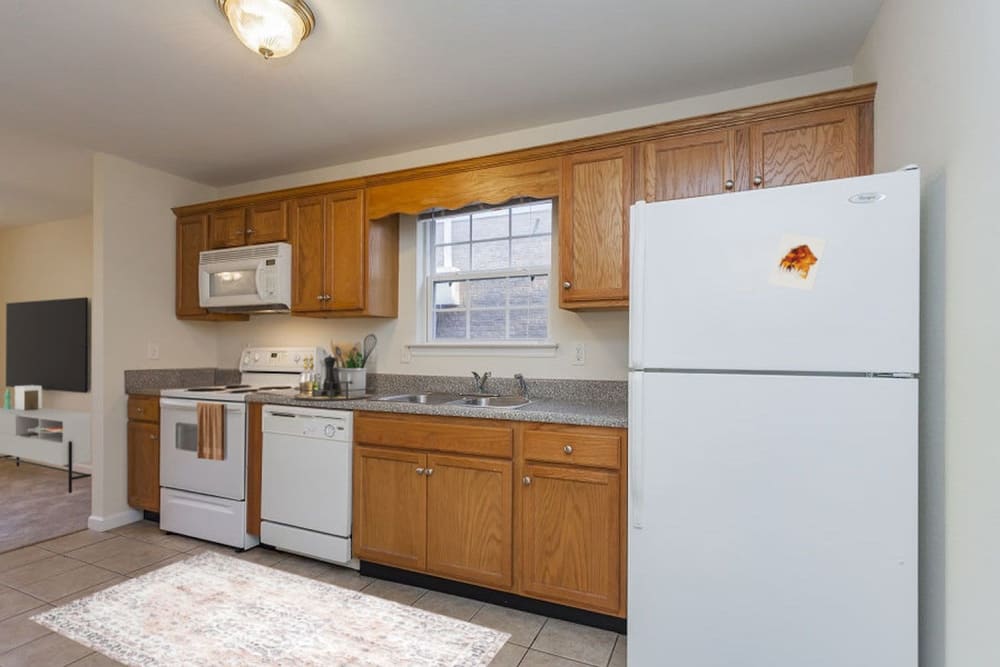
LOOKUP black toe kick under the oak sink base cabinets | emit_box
[361,560,628,634]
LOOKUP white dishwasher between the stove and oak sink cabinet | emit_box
[260,405,357,567]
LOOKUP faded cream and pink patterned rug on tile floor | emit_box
[32,552,510,667]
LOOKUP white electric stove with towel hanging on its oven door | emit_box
[160,347,327,549]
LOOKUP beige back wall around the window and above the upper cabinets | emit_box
[216,68,853,380]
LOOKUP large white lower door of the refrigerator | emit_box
[628,373,917,667]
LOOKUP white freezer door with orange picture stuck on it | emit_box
[629,170,920,373]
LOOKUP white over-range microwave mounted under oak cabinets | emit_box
[198,243,292,313]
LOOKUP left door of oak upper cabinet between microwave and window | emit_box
[290,197,326,313]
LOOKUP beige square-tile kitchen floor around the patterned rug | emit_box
[0,521,626,667]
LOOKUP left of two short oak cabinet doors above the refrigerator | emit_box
[642,130,746,201]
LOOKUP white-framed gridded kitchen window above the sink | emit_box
[420,200,552,343]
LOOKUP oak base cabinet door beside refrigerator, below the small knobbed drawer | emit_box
[519,465,622,613]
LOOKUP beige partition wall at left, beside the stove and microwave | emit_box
[90,154,218,529]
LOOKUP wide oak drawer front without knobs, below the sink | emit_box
[354,412,514,459]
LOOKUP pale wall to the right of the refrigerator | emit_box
[855,0,1000,667]
